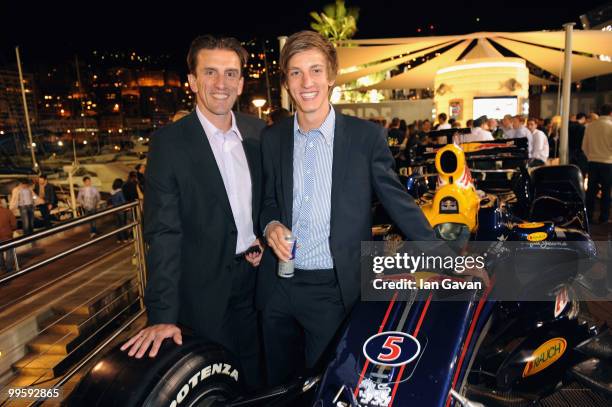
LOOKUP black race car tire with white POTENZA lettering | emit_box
[66,337,243,407]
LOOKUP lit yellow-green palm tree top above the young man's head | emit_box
[310,0,359,42]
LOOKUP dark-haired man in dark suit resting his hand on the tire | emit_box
[122,36,264,387]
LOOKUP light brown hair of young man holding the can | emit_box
[279,31,338,83]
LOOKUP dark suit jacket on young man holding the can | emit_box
[257,111,436,311]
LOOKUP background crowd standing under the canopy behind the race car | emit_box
[370,104,612,223]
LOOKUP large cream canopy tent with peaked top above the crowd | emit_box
[336,30,612,89]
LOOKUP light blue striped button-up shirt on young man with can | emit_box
[291,106,336,270]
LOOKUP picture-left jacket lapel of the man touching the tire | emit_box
[187,110,234,222]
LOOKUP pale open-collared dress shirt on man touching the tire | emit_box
[196,106,255,254]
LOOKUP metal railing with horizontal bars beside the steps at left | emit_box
[0,201,146,405]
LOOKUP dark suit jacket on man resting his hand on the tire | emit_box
[144,111,264,336]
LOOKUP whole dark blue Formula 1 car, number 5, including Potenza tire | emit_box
[67,135,612,407]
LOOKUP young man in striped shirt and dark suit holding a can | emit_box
[257,31,435,385]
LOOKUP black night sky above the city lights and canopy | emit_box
[0,0,607,67]
